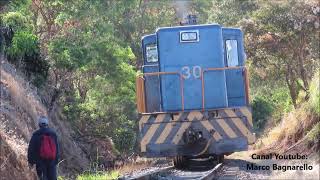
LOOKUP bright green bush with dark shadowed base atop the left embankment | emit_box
[0,8,49,87]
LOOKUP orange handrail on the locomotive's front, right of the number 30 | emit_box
[201,66,249,111]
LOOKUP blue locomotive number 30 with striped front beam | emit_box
[136,16,255,167]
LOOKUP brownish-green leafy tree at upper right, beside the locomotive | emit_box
[241,1,319,107]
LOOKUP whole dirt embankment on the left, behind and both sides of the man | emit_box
[0,59,89,179]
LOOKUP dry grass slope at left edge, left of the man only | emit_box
[0,61,46,179]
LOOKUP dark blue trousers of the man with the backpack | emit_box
[36,161,57,180]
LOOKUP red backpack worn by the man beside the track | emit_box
[40,134,57,160]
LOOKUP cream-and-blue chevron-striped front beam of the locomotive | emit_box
[139,107,255,152]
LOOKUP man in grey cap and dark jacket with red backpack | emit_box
[28,116,59,180]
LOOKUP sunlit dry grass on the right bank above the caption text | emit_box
[255,71,320,150]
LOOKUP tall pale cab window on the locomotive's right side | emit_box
[226,40,239,67]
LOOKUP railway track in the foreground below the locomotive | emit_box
[120,163,222,180]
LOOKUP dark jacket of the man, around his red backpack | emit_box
[28,127,60,165]
